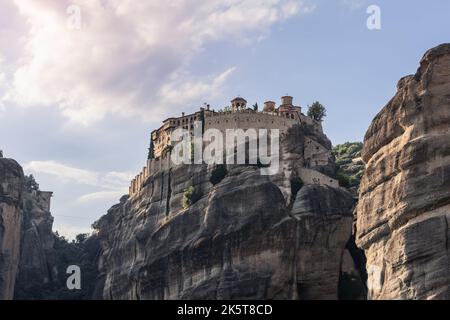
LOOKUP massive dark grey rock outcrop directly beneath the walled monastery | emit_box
[96,126,353,299]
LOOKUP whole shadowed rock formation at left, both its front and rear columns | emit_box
[0,158,57,300]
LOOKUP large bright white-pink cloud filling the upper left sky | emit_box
[0,0,312,125]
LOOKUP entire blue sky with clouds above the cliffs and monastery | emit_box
[0,0,450,237]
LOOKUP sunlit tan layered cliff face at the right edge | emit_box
[357,44,450,299]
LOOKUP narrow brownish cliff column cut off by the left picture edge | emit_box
[0,158,24,299]
